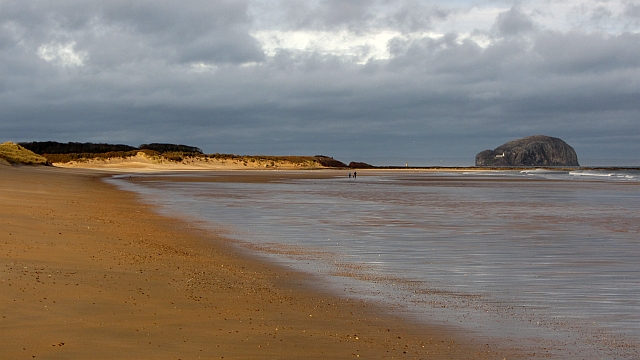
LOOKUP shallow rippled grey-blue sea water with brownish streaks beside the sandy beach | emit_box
[108,170,640,359]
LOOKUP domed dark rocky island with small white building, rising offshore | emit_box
[476,135,580,166]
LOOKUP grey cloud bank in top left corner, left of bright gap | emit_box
[0,0,264,64]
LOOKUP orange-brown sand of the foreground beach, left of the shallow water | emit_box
[0,166,514,359]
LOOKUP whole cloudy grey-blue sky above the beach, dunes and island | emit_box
[0,0,640,166]
